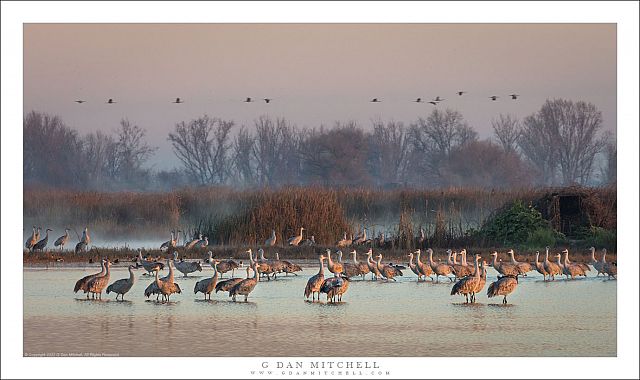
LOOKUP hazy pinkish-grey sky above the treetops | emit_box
[24,24,616,169]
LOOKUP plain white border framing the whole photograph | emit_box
[1,2,639,378]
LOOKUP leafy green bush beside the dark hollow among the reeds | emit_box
[482,201,557,247]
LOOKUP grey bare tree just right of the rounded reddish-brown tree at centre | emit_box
[369,121,411,185]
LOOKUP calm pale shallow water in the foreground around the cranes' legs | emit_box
[24,266,616,356]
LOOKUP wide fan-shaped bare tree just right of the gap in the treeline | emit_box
[168,115,233,184]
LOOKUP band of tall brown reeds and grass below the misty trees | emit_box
[24,187,616,247]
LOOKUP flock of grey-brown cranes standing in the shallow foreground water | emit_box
[65,228,617,304]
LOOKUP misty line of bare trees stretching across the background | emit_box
[24,99,617,190]
